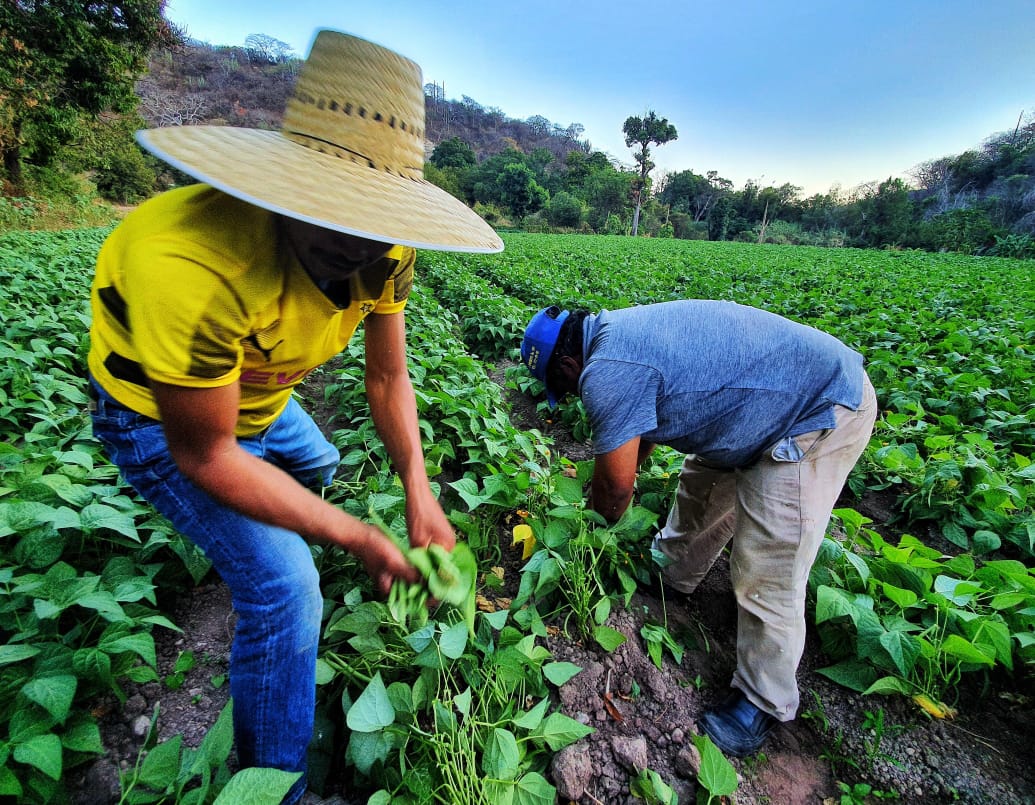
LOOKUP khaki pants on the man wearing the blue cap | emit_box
[654,379,877,721]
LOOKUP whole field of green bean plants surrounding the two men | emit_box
[0,230,1035,803]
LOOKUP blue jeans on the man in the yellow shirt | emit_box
[91,381,339,803]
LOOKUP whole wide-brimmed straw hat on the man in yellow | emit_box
[137,30,503,252]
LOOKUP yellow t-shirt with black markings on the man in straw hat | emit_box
[89,184,415,436]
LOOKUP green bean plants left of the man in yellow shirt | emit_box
[0,230,205,803]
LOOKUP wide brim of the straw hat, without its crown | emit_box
[137,126,503,254]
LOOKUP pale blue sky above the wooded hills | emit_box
[166,0,1035,195]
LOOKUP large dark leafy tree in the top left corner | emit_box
[0,0,177,186]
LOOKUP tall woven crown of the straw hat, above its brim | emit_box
[282,31,424,180]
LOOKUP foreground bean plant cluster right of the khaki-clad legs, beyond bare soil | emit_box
[809,509,1035,703]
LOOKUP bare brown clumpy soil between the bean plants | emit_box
[72,360,1035,805]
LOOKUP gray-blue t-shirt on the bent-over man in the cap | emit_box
[579,300,863,467]
